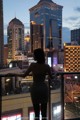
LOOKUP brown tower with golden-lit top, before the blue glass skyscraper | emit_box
[30,22,43,52]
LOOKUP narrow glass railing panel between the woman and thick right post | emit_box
[50,75,61,120]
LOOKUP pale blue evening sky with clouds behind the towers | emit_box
[3,0,80,41]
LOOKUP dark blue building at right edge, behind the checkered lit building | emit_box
[71,28,80,45]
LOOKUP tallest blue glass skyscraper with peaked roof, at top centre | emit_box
[29,0,63,50]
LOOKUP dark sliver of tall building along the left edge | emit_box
[0,0,4,68]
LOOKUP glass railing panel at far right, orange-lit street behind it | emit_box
[64,74,80,120]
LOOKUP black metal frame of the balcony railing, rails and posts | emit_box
[0,72,80,120]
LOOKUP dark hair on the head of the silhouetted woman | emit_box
[34,48,45,63]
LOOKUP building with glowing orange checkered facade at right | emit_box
[64,44,80,72]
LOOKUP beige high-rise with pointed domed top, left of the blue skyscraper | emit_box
[8,18,24,59]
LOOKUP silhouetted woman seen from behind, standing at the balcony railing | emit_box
[9,48,52,120]
